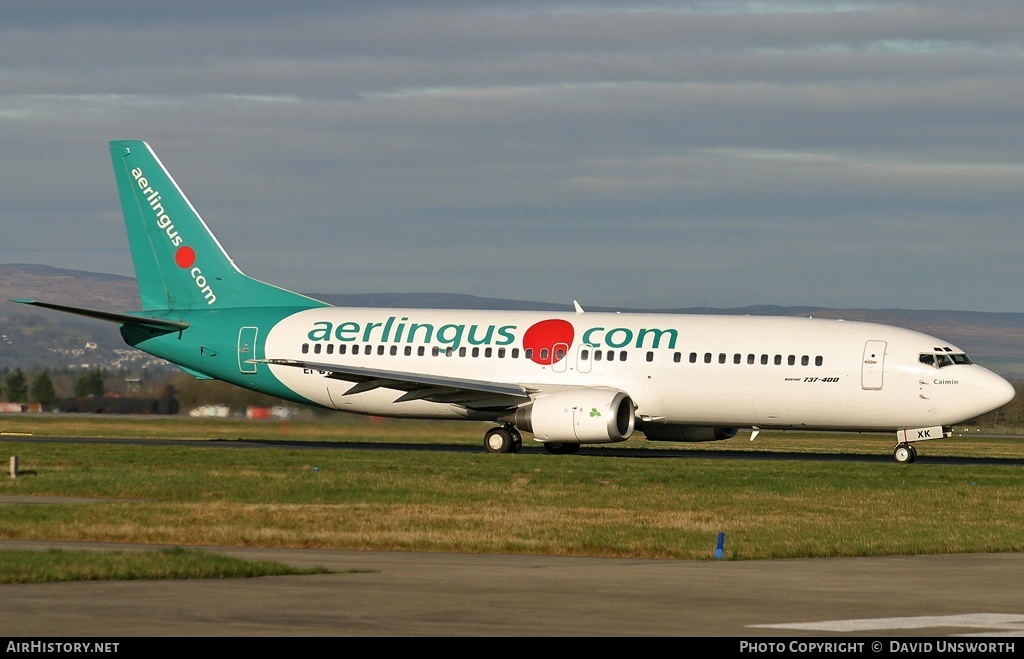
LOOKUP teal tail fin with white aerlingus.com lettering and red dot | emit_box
[111,140,327,311]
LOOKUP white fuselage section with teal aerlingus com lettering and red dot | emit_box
[264,307,1013,431]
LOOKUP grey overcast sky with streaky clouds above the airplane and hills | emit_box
[0,0,1024,311]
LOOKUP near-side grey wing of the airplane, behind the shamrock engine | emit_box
[253,359,538,409]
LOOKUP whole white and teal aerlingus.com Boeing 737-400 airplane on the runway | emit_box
[16,140,1014,463]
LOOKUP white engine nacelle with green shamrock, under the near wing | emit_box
[510,389,636,444]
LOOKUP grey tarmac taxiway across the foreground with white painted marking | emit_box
[0,540,1024,636]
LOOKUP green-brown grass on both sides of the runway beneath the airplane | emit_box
[6,416,1024,559]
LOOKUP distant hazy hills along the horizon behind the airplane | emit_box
[0,264,1024,378]
